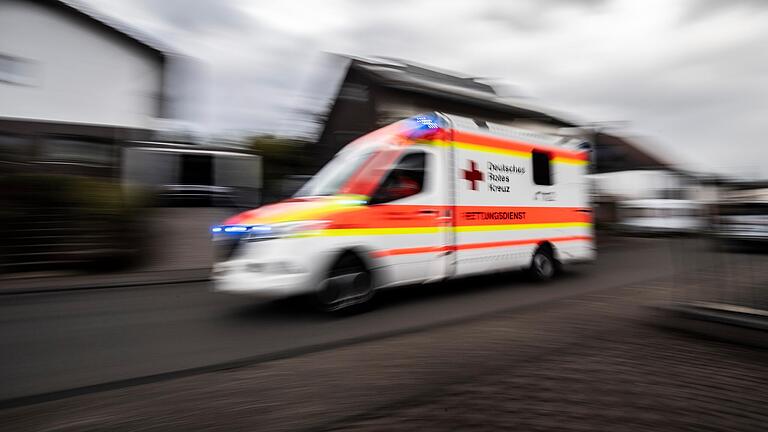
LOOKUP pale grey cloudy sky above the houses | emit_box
[81,0,768,178]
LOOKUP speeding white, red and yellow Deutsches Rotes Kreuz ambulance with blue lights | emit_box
[211,113,595,311]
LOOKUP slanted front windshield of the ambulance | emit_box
[294,149,373,197]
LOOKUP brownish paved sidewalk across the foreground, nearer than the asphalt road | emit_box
[0,285,768,432]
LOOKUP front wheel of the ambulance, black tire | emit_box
[315,253,374,312]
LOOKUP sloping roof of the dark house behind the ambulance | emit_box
[349,57,577,126]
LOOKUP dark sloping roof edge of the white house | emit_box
[37,0,170,59]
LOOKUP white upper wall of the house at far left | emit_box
[0,0,162,128]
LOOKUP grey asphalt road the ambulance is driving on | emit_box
[0,239,674,401]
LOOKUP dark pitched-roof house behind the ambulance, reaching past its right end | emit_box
[317,57,668,172]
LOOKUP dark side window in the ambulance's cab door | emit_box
[371,151,427,204]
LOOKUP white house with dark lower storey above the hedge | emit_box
[0,0,168,175]
